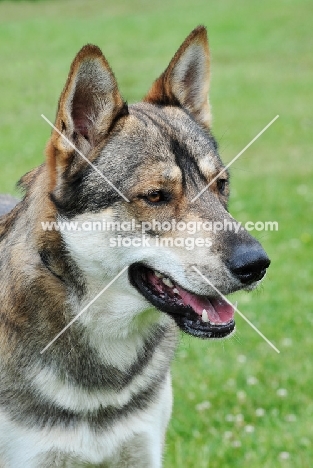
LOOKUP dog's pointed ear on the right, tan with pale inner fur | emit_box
[144,26,211,128]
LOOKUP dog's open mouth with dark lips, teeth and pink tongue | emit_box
[129,263,235,338]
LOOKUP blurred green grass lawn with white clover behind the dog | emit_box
[0,0,313,468]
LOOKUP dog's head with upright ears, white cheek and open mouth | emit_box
[47,27,269,338]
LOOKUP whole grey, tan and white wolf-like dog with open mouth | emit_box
[0,26,270,468]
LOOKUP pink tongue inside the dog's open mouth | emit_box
[176,285,234,324]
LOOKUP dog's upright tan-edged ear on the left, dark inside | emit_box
[46,44,128,187]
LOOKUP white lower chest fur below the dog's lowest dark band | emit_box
[0,378,171,468]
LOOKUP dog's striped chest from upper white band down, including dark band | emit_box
[0,346,171,468]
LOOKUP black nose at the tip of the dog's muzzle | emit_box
[228,245,271,284]
